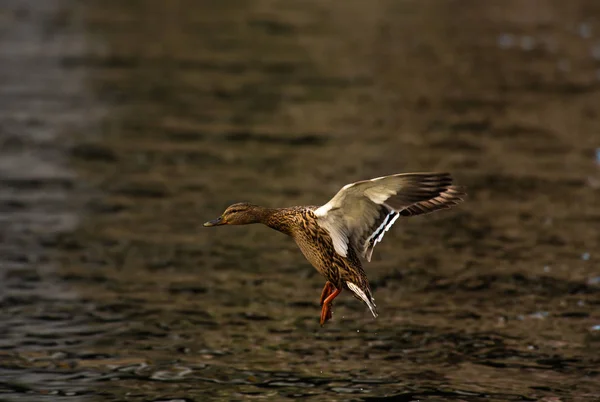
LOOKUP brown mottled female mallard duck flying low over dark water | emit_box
[204,173,466,326]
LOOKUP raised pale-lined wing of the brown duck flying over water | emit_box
[315,173,465,261]
